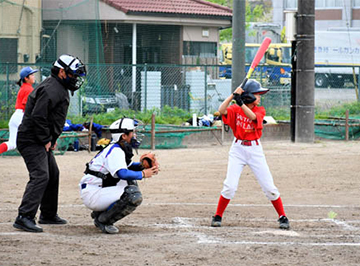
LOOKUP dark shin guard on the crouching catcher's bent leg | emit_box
[98,185,142,224]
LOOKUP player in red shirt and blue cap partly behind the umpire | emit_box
[0,67,39,154]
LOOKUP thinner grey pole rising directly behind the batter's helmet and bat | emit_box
[231,0,245,91]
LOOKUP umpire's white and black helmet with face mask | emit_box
[54,55,86,91]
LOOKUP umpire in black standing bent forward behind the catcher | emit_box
[13,55,86,232]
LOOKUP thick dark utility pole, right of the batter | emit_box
[291,0,315,143]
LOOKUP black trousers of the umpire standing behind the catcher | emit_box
[18,141,59,219]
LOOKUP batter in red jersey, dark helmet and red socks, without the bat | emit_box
[211,79,290,229]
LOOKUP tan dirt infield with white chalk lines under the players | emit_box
[0,141,360,266]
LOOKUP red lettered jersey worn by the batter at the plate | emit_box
[222,104,266,140]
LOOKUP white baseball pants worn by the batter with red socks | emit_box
[221,139,280,201]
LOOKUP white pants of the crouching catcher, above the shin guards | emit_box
[80,181,127,211]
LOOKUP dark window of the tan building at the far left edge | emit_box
[0,38,18,73]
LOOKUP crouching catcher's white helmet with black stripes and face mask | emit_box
[109,117,143,149]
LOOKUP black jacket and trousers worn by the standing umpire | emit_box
[17,74,69,219]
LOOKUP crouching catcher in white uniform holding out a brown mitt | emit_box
[79,118,159,234]
